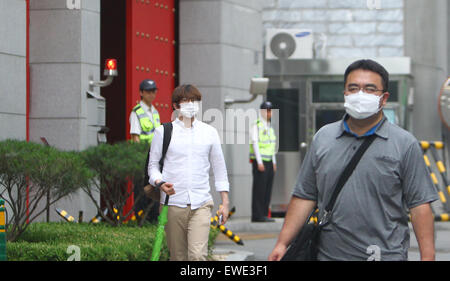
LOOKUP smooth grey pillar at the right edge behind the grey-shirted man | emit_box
[405,0,449,140]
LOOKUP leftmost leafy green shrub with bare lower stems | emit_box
[0,140,92,241]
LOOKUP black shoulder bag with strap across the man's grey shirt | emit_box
[281,134,376,261]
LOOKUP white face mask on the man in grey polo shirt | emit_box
[344,91,384,119]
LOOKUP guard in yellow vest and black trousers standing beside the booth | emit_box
[250,101,277,222]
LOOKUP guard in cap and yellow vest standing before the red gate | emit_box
[130,79,161,221]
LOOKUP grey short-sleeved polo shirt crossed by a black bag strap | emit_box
[293,115,439,260]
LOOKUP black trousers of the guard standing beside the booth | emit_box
[252,160,274,220]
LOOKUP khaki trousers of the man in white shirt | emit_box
[165,201,214,261]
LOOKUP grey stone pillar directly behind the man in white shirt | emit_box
[180,0,263,216]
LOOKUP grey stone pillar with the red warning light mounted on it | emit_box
[30,0,100,220]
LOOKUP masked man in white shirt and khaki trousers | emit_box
[149,85,229,261]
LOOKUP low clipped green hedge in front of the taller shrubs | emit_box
[6,222,219,261]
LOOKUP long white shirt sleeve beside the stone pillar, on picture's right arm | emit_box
[210,129,230,192]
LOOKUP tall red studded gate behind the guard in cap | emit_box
[124,0,177,217]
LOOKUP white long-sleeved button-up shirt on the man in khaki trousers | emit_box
[149,119,229,209]
